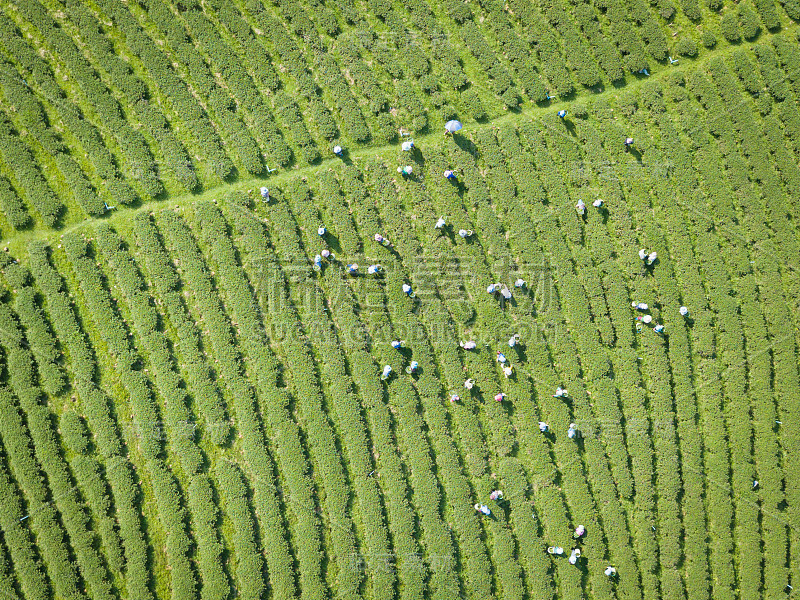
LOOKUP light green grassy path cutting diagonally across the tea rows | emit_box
[3,22,798,254]
